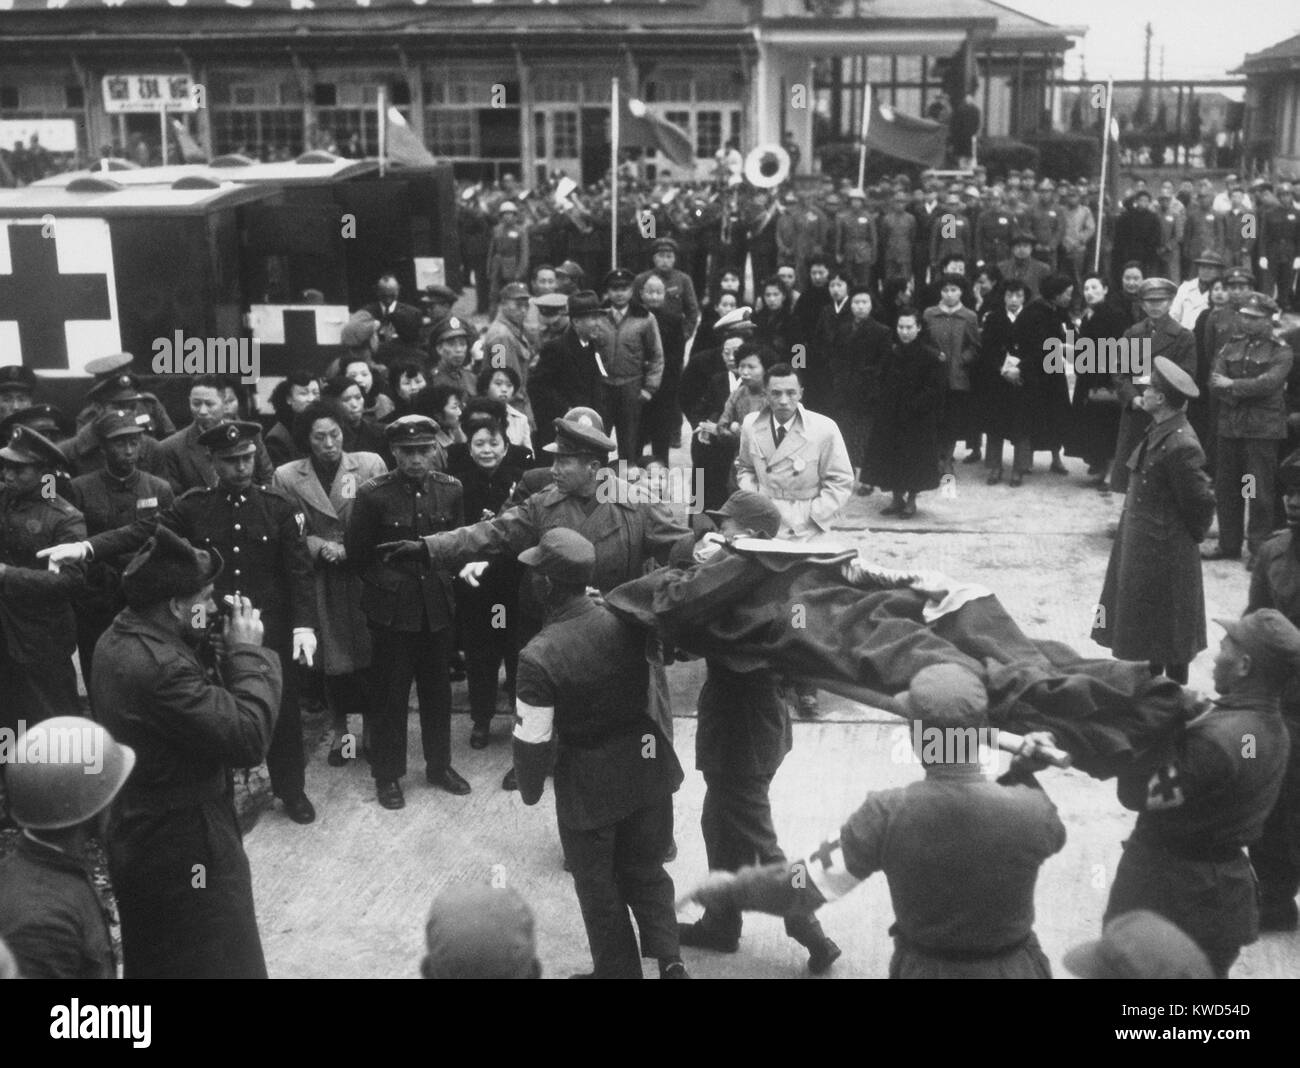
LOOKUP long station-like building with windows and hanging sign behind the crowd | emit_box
[0,0,1082,184]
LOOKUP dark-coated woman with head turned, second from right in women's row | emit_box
[1015,274,1074,474]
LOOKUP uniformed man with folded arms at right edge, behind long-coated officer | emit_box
[1204,292,1294,569]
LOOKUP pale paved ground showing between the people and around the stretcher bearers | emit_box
[247,444,1300,978]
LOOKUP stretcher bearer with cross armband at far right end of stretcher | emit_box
[1105,608,1300,978]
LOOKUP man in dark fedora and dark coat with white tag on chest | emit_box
[533,290,611,448]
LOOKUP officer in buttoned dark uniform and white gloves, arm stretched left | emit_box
[43,422,316,824]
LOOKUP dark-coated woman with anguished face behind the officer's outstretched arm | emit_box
[447,398,533,750]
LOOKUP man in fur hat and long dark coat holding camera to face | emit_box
[91,535,281,980]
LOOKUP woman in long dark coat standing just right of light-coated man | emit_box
[862,305,948,518]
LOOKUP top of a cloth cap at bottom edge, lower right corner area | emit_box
[1065,908,1214,980]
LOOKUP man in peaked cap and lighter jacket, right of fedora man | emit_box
[598,268,663,464]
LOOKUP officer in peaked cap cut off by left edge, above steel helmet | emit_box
[0,425,86,729]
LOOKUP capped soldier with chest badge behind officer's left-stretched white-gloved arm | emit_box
[70,411,173,696]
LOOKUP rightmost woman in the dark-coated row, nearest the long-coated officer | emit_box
[1066,272,1130,486]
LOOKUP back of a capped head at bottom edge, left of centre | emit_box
[420,884,542,980]
